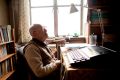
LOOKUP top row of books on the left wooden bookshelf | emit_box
[0,25,13,43]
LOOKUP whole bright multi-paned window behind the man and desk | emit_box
[31,0,87,36]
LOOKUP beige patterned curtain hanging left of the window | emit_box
[11,0,31,44]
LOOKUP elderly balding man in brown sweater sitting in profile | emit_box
[24,24,61,80]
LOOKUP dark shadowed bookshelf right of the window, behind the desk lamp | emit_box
[88,0,115,46]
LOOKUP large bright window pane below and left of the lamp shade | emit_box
[58,7,80,35]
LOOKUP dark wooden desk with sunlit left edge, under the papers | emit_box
[61,44,116,80]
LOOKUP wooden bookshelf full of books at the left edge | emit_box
[0,25,16,80]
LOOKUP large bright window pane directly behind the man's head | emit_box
[31,8,54,36]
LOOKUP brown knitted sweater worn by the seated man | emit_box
[24,39,56,78]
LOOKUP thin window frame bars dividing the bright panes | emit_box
[30,0,85,37]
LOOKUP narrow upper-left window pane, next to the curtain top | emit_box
[31,0,53,7]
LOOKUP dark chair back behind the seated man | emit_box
[16,46,40,80]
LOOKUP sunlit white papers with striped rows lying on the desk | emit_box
[65,44,100,65]
